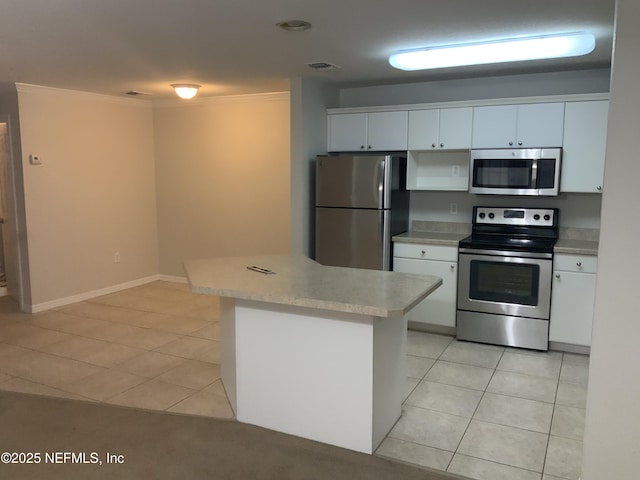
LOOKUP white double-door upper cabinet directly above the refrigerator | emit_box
[328,111,409,152]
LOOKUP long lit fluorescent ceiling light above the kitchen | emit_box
[389,32,596,70]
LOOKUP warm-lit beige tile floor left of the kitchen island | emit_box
[0,282,233,418]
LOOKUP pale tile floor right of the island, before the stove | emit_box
[376,331,589,480]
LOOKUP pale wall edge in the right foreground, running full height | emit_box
[582,0,640,480]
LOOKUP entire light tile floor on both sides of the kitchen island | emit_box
[0,282,588,480]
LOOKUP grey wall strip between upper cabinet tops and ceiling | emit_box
[333,68,610,107]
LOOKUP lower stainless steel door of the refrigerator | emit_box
[316,207,391,270]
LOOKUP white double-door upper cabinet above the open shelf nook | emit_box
[409,107,473,150]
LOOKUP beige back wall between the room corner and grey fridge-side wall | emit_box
[154,94,291,277]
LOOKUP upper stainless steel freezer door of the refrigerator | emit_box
[316,155,391,208]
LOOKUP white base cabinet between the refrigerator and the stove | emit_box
[393,242,458,328]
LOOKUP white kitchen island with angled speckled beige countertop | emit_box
[185,255,442,453]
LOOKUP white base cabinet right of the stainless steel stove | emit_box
[549,254,598,346]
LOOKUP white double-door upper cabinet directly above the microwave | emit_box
[471,102,565,148]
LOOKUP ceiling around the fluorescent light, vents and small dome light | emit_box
[0,0,615,99]
